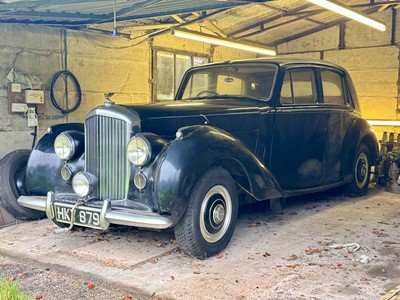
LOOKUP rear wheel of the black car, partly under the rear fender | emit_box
[345,144,371,196]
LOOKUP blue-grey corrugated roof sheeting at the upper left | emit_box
[0,0,268,24]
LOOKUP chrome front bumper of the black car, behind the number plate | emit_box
[18,192,172,230]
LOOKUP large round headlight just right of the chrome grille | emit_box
[127,135,151,166]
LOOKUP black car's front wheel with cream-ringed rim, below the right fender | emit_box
[174,167,238,259]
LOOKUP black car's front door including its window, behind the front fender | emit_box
[270,66,326,194]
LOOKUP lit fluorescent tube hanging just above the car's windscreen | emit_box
[172,30,276,56]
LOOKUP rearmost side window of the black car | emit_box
[321,70,346,105]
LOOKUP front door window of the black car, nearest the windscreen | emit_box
[281,68,317,104]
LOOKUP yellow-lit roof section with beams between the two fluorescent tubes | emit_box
[208,0,377,45]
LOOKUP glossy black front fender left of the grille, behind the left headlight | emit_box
[25,123,84,196]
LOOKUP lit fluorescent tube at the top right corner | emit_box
[308,0,386,31]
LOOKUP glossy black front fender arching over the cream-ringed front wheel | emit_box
[154,126,283,222]
